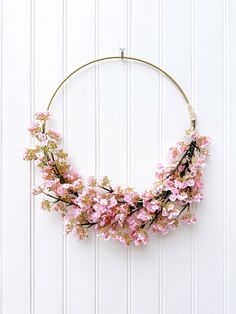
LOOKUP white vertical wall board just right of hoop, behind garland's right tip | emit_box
[196,0,226,314]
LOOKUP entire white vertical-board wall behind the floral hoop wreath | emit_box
[0,0,236,314]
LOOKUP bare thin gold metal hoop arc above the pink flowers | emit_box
[44,55,196,129]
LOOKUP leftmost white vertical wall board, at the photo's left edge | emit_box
[1,0,30,314]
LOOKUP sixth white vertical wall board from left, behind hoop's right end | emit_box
[162,0,194,314]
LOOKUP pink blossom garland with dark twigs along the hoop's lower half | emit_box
[24,112,210,246]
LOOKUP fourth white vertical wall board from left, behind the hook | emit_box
[96,0,128,314]
